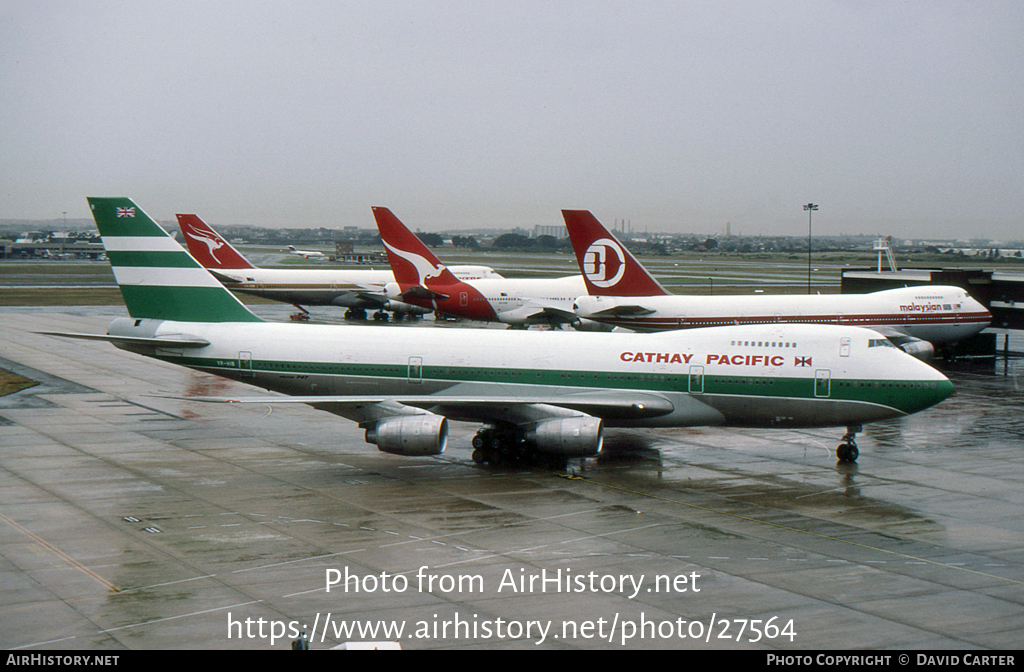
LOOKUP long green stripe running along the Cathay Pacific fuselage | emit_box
[159,356,950,413]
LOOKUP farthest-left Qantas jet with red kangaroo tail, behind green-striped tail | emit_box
[177,214,501,320]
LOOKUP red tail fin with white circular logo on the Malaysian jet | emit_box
[562,210,669,296]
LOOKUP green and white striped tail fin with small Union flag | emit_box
[89,198,262,322]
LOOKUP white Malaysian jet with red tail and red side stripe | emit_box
[562,210,992,359]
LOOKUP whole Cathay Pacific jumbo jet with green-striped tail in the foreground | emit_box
[48,198,953,462]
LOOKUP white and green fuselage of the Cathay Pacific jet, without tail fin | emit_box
[110,319,952,426]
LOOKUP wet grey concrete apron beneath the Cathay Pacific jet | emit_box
[0,307,1024,653]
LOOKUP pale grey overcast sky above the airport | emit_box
[0,0,1024,239]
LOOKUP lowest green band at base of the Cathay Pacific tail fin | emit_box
[121,285,263,322]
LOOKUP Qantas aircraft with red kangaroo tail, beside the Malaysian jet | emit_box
[373,208,593,327]
